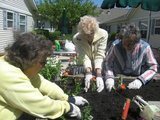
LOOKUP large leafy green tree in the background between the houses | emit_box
[34,0,99,34]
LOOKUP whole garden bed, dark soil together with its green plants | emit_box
[42,57,160,120]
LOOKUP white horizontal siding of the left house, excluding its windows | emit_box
[0,0,34,53]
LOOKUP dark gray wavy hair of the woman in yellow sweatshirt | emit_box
[5,33,52,71]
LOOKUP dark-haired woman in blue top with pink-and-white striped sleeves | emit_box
[104,24,158,91]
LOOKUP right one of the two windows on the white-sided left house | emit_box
[19,15,26,32]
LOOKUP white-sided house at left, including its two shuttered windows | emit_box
[0,0,36,53]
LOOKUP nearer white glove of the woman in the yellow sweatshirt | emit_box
[67,103,81,120]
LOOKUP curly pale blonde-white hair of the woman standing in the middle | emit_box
[78,15,99,34]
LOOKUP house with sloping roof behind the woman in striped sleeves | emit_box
[98,7,160,48]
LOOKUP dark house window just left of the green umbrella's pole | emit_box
[139,20,148,38]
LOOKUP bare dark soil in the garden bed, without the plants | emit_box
[81,81,160,120]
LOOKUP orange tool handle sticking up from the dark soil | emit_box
[121,98,131,120]
